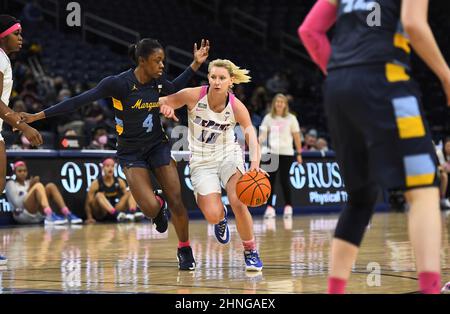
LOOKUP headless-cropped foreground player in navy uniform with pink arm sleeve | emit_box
[299,0,450,293]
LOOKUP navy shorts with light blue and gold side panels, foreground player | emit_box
[324,63,438,192]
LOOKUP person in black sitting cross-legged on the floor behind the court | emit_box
[85,158,145,224]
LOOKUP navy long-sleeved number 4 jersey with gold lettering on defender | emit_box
[44,67,194,148]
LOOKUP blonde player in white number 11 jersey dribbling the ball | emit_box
[159,60,263,271]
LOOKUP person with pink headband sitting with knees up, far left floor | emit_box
[6,161,83,225]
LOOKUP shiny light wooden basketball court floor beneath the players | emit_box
[0,213,450,294]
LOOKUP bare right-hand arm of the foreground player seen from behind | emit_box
[401,0,450,106]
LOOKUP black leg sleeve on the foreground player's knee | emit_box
[334,184,378,247]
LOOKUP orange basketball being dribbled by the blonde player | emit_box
[236,171,271,207]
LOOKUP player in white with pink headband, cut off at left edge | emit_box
[0,15,42,265]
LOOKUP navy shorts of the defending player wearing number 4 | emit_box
[117,141,172,169]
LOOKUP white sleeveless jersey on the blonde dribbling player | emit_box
[188,86,239,160]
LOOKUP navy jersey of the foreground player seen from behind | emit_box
[328,0,411,70]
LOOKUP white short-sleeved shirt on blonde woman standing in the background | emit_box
[260,113,300,156]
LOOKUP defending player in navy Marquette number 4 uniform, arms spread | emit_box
[21,38,209,270]
